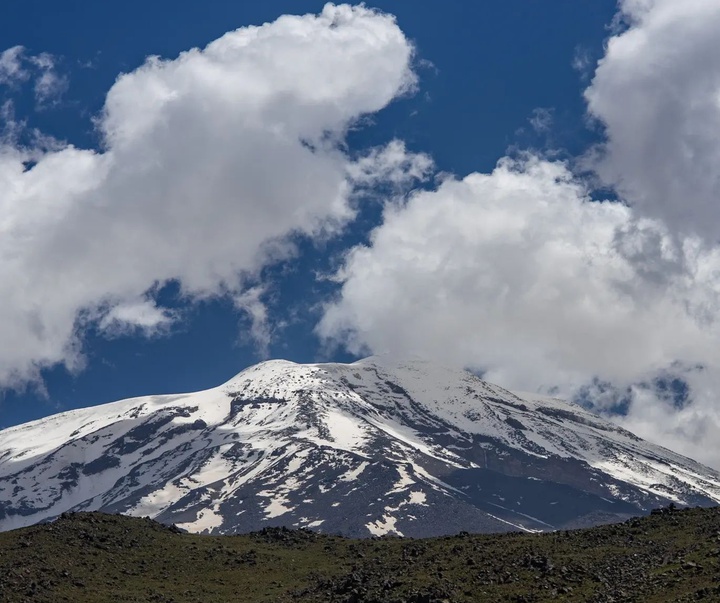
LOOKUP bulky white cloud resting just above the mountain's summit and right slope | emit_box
[318,156,720,468]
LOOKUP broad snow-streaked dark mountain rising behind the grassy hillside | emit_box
[0,358,720,536]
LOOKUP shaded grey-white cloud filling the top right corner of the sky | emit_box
[585,0,720,243]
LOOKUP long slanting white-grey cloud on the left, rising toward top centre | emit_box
[0,5,416,385]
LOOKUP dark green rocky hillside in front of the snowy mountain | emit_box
[0,508,720,603]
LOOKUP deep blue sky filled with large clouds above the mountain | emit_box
[0,0,720,470]
